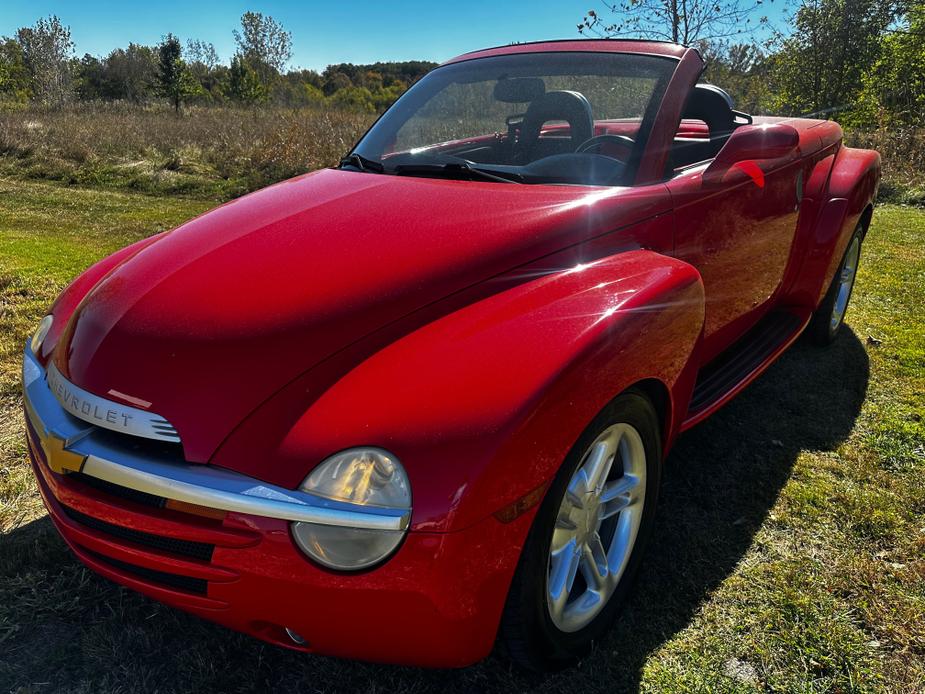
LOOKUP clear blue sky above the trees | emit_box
[0,0,788,69]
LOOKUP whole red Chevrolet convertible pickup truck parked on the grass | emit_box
[23,40,880,668]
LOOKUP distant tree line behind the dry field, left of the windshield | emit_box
[0,12,436,113]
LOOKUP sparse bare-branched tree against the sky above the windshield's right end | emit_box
[578,0,774,46]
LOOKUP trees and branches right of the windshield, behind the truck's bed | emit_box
[578,0,925,131]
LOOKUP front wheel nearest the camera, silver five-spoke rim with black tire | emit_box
[501,391,661,670]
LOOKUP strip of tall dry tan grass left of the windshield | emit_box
[0,103,372,197]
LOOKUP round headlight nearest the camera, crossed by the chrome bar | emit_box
[292,448,411,571]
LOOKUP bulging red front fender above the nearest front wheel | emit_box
[213,250,704,531]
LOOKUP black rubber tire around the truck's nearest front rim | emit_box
[500,390,662,672]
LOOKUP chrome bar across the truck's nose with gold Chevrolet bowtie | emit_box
[23,345,411,530]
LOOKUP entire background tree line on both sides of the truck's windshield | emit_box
[0,0,925,130]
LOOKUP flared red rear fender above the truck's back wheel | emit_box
[789,147,880,309]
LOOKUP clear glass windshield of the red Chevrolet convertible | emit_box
[341,52,677,185]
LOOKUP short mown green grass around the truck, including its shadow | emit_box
[0,178,925,694]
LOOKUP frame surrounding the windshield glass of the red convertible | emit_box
[341,49,681,187]
